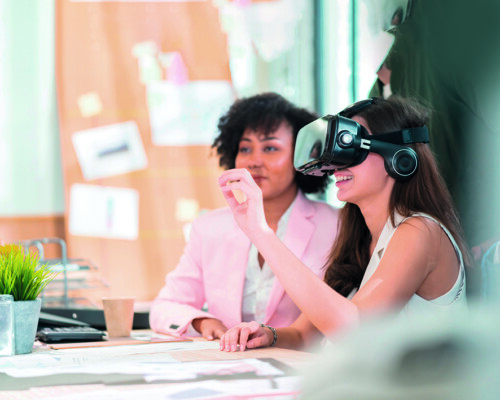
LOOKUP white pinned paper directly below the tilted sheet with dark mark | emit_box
[69,184,139,240]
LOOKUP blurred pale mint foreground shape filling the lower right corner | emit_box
[302,303,500,400]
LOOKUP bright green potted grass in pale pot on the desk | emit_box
[0,245,56,354]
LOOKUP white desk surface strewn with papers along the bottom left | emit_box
[0,332,316,400]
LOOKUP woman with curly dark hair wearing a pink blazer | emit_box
[150,93,337,339]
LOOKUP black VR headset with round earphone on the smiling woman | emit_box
[294,113,429,181]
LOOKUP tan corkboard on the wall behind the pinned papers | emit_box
[56,0,231,301]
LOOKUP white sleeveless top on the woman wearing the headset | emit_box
[360,213,467,316]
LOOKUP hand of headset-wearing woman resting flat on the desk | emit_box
[219,321,274,351]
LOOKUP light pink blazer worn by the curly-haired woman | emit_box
[150,192,338,335]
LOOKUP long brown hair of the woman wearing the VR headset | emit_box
[325,96,470,296]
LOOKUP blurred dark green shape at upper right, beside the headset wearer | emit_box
[384,0,500,247]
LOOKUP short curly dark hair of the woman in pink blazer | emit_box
[212,92,331,193]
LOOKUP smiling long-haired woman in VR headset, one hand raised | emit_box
[219,96,469,351]
